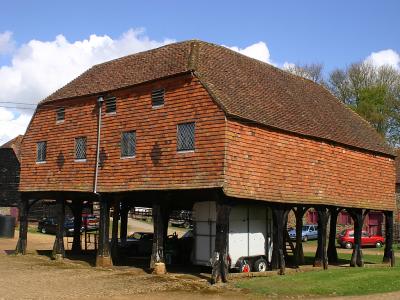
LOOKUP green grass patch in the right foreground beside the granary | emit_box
[236,267,400,297]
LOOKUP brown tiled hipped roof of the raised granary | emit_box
[40,40,393,155]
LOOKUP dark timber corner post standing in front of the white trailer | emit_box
[211,194,231,284]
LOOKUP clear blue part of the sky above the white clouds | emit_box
[0,0,400,70]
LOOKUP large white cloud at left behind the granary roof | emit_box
[0,29,173,144]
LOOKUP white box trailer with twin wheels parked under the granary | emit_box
[192,201,272,272]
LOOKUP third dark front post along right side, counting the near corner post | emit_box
[314,207,329,270]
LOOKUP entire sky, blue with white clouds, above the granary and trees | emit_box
[0,0,400,144]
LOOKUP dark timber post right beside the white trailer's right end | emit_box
[271,206,286,275]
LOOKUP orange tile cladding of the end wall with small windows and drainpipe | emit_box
[21,75,225,192]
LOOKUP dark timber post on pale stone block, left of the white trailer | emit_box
[150,199,168,274]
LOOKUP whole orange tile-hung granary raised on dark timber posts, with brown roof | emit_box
[17,40,395,278]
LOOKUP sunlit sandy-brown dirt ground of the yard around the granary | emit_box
[0,223,400,300]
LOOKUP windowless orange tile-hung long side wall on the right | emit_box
[224,120,395,210]
